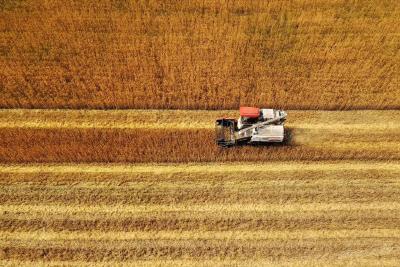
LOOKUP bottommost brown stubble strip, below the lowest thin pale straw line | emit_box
[0,239,400,261]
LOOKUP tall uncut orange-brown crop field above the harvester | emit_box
[0,0,400,109]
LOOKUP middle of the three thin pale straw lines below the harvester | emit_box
[0,201,400,213]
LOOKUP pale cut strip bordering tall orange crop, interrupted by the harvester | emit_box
[0,109,400,130]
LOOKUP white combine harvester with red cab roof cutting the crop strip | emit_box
[215,107,287,147]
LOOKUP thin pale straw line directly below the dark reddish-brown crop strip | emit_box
[0,161,400,174]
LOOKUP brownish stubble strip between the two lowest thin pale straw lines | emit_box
[0,208,400,234]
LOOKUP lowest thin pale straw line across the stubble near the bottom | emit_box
[0,229,400,242]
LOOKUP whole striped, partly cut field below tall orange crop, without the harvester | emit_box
[0,109,400,266]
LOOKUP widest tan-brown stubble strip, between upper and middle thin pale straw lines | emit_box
[0,172,400,205]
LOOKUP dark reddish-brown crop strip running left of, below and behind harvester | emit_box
[0,128,400,163]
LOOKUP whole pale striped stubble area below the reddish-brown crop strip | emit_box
[0,161,400,266]
